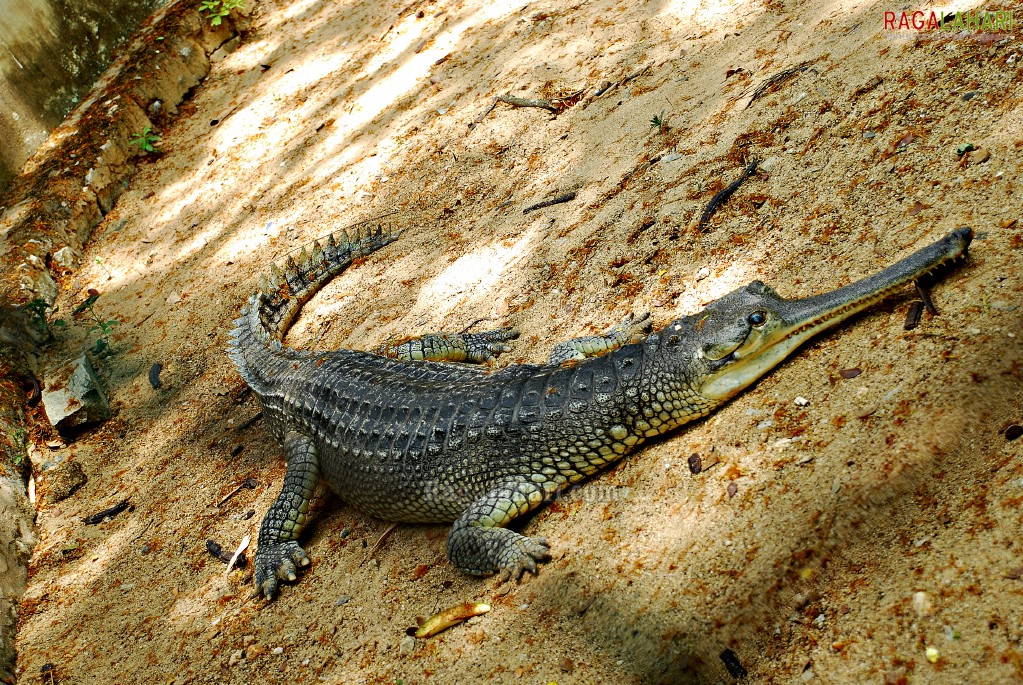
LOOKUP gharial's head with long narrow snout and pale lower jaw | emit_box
[698,228,973,402]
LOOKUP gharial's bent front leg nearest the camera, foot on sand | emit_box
[447,478,550,579]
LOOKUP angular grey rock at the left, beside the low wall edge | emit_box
[43,354,113,431]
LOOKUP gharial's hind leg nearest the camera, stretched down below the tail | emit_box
[256,430,319,599]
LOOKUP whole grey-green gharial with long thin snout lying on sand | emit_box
[228,222,973,598]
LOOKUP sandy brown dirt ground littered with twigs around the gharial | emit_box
[9,0,1023,685]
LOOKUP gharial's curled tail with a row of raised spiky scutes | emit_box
[227,226,398,392]
